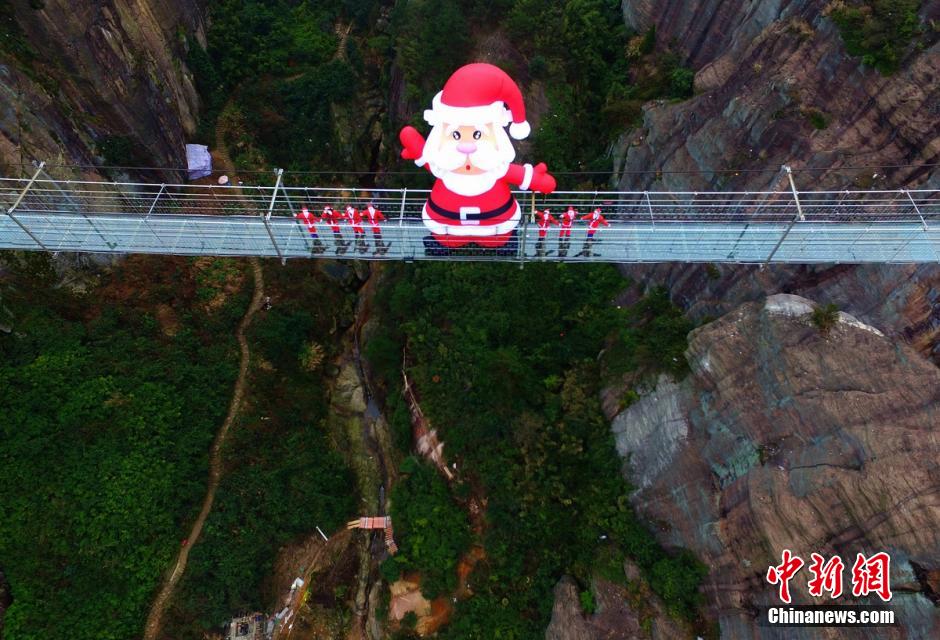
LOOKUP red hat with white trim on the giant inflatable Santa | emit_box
[424,62,532,140]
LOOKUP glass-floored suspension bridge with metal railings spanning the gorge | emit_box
[0,164,940,264]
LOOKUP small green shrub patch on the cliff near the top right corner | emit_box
[831,0,921,75]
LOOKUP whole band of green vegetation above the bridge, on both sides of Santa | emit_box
[187,0,694,186]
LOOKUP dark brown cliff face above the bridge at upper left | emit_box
[0,0,205,176]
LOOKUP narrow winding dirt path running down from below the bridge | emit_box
[144,258,264,640]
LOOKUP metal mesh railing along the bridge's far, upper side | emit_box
[0,178,940,222]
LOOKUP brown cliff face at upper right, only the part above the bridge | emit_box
[621,0,940,189]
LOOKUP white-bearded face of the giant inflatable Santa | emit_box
[424,123,516,196]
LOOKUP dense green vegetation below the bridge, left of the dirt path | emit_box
[0,254,247,640]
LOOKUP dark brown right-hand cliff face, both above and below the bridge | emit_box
[618,0,940,362]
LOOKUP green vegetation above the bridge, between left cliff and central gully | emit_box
[187,0,360,175]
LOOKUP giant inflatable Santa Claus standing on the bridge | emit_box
[399,62,555,255]
